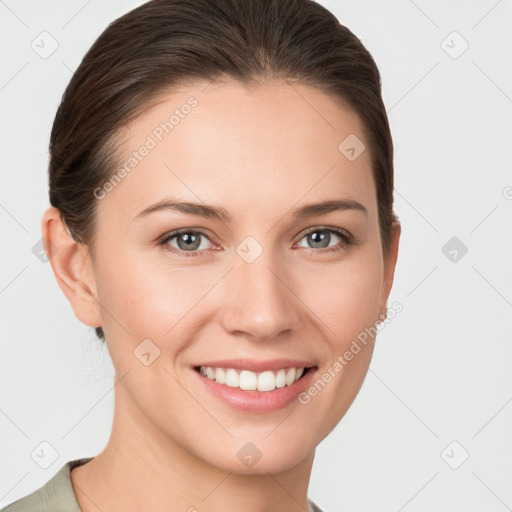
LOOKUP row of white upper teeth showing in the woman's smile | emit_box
[199,366,304,391]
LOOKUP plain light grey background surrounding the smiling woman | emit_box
[0,0,512,512]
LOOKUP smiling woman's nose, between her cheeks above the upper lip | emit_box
[221,251,302,341]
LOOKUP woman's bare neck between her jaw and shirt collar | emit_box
[71,376,314,512]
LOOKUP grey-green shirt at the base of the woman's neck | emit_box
[0,457,324,512]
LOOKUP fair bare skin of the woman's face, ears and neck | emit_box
[42,81,400,512]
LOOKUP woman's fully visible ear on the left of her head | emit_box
[41,206,102,327]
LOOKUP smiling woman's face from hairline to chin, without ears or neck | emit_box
[60,78,398,473]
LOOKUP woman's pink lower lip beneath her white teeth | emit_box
[193,368,316,412]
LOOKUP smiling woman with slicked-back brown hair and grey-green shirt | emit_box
[4,0,400,512]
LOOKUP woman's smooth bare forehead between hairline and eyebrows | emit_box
[100,81,376,219]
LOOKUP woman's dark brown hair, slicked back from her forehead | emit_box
[49,0,395,340]
